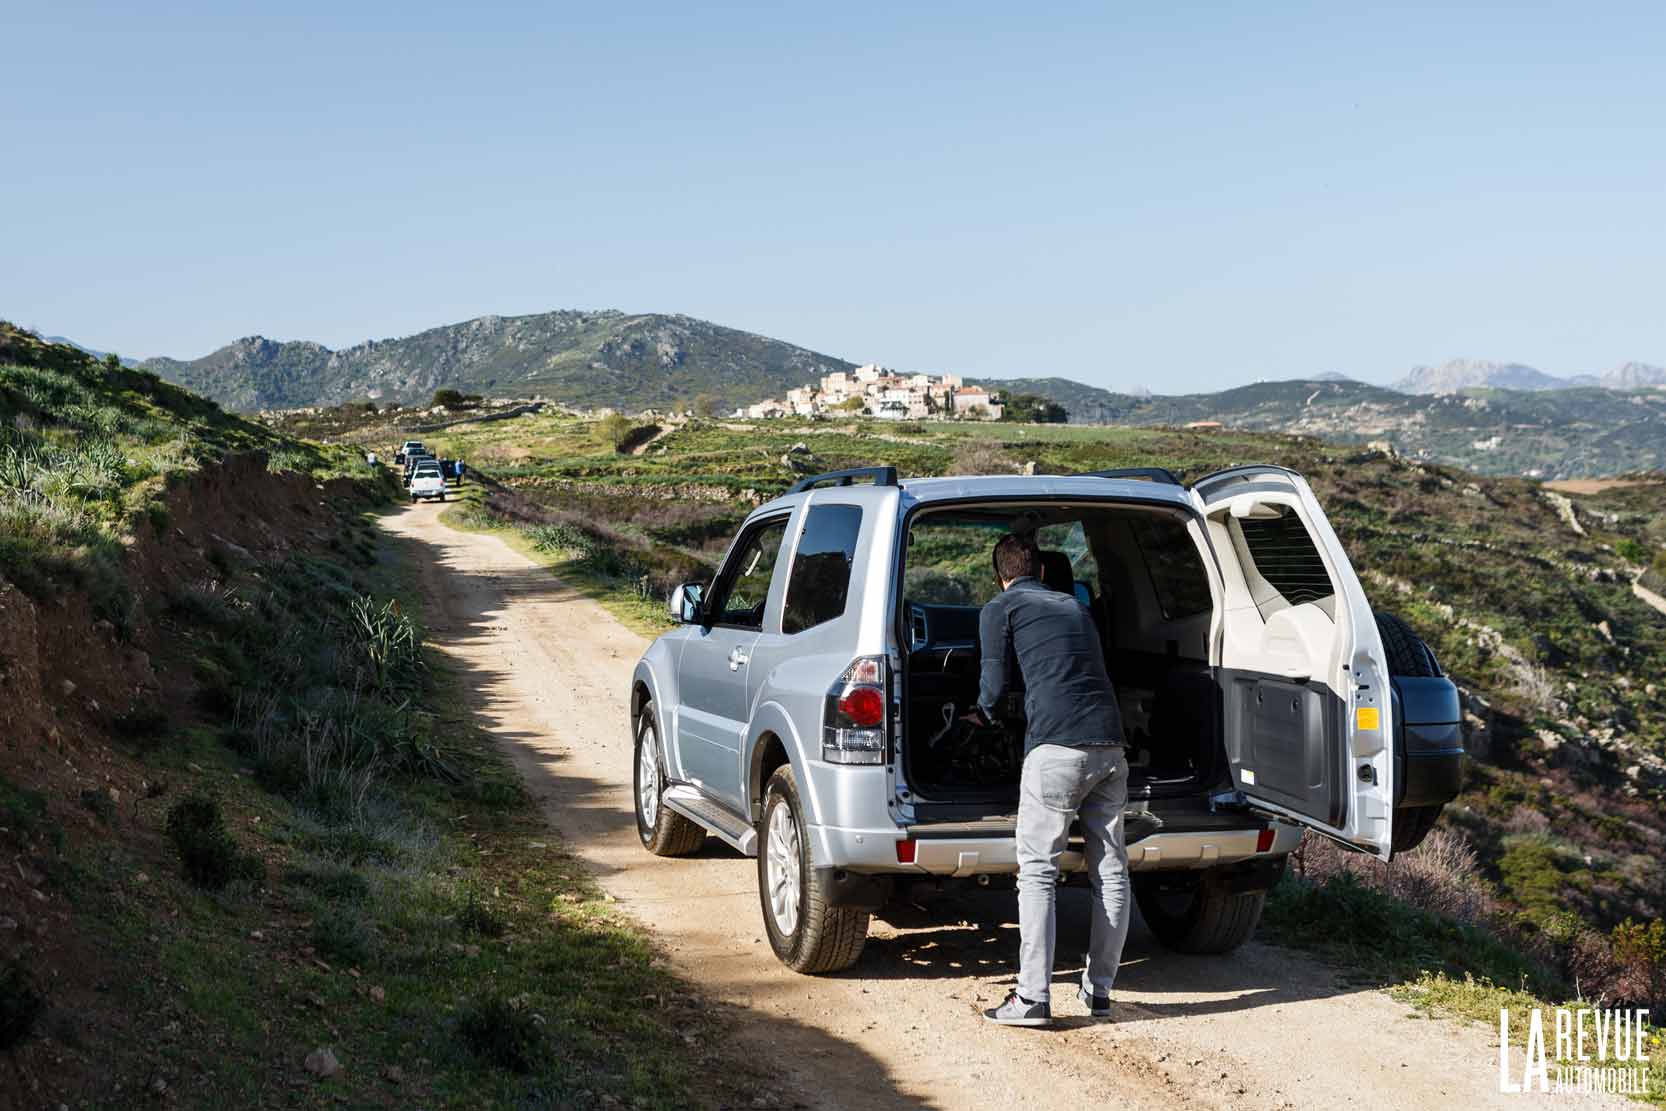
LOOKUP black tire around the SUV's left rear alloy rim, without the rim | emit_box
[758,765,871,973]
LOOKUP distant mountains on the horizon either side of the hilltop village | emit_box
[58,311,1666,478]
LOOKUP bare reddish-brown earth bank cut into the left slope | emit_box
[0,455,386,1106]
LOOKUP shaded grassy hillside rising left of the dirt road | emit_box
[0,330,751,1108]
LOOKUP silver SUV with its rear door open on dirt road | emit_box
[630,466,1463,973]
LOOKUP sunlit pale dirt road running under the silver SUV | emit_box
[387,505,1623,1111]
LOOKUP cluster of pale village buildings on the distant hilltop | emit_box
[735,363,1005,420]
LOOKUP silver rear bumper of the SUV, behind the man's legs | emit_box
[811,821,1301,876]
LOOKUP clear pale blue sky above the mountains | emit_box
[0,0,1666,393]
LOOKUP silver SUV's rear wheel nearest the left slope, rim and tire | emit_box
[758,765,871,973]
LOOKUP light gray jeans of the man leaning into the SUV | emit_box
[1018,745,1130,1003]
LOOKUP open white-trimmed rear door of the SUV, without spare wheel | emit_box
[1191,466,1394,859]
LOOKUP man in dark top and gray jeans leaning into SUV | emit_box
[965,533,1130,1026]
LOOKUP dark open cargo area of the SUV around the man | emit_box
[900,501,1225,813]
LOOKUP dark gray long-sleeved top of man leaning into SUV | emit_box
[978,575,1125,756]
